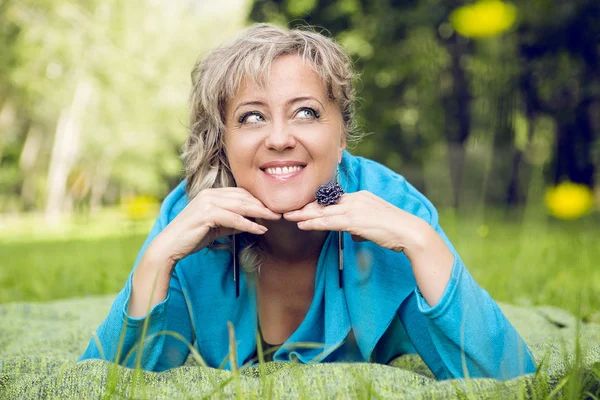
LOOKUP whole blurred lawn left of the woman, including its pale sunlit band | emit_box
[0,209,152,303]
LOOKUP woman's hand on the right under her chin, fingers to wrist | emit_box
[283,190,436,256]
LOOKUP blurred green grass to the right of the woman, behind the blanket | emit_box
[441,213,600,322]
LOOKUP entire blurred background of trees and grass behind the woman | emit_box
[0,0,600,322]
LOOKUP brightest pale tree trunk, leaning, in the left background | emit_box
[45,79,92,223]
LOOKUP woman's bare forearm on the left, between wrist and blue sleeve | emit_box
[128,244,174,318]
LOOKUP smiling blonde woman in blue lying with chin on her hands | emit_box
[81,24,535,379]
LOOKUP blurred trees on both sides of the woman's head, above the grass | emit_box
[0,0,600,213]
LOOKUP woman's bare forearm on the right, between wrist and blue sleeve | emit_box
[404,222,454,307]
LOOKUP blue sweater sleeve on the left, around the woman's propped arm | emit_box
[79,211,193,371]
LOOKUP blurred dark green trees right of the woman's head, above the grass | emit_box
[250,0,600,205]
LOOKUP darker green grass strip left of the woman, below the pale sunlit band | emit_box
[0,235,144,303]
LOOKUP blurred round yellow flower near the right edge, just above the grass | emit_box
[546,182,594,219]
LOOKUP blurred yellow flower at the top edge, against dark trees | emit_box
[450,0,517,38]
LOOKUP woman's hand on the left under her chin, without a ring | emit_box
[150,187,281,266]
